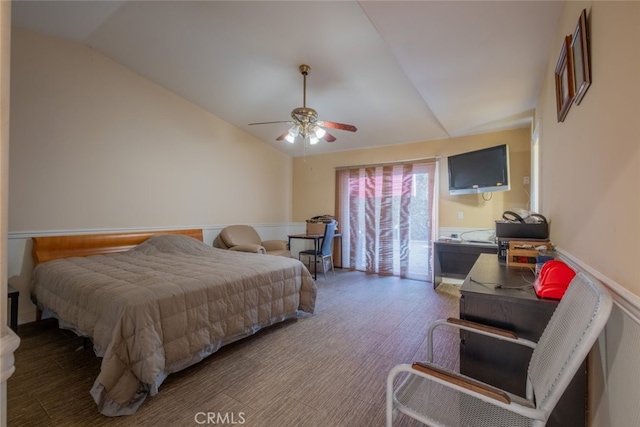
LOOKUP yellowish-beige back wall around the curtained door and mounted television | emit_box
[293,128,531,228]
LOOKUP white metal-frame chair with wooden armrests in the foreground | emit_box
[386,273,612,427]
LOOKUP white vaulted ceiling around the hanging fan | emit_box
[12,0,563,156]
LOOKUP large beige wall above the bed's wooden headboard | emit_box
[9,29,292,232]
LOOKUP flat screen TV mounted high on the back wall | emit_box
[448,144,510,195]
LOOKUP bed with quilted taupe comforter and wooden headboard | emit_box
[32,230,316,416]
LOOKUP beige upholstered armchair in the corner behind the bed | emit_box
[213,225,291,258]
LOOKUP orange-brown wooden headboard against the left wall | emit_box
[31,228,203,266]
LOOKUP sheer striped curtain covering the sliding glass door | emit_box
[336,159,438,280]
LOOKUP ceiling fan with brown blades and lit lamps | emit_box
[249,64,358,145]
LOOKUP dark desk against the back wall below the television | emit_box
[433,240,498,289]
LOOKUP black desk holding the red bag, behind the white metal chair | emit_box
[460,254,587,427]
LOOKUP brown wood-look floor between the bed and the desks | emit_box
[7,269,459,427]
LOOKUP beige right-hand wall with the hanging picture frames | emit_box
[536,1,640,295]
